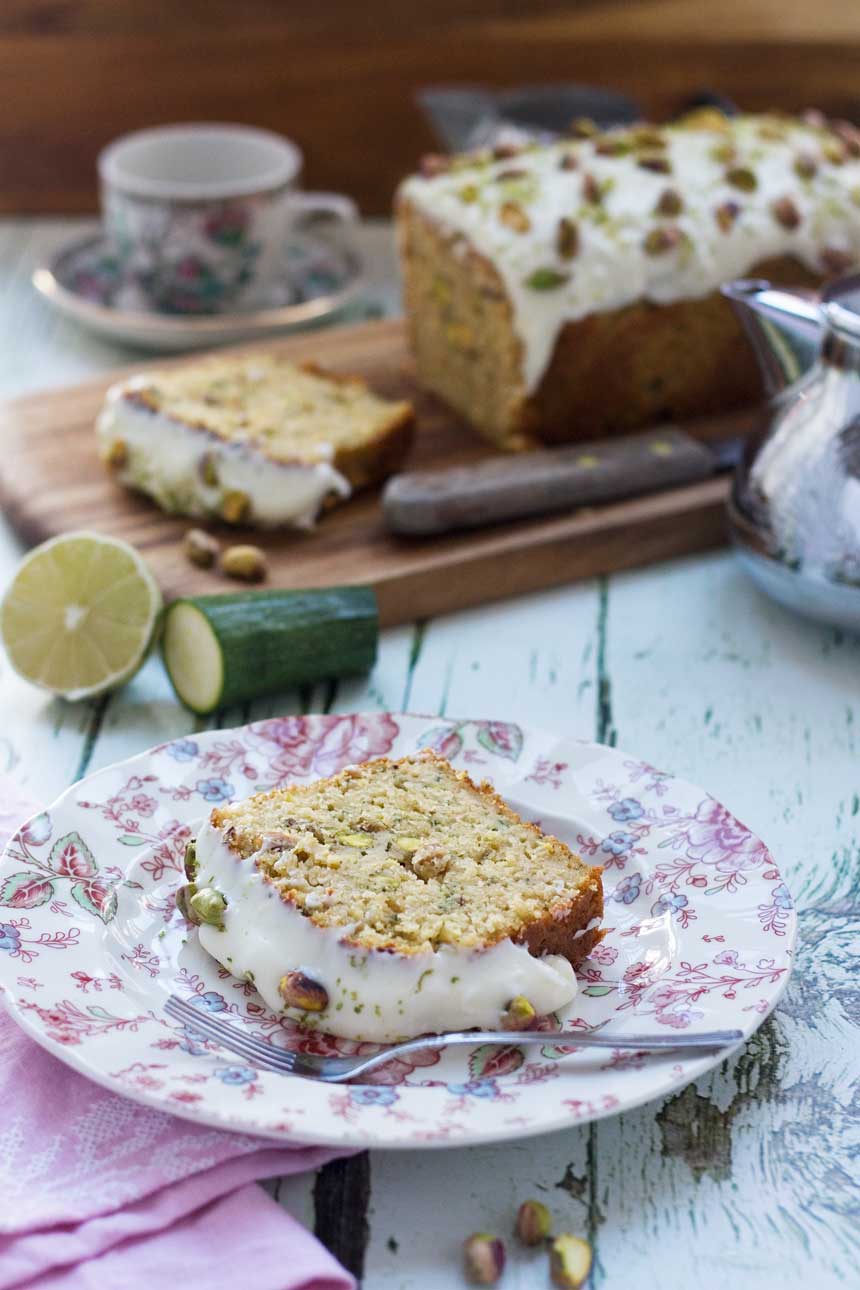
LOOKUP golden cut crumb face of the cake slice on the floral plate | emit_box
[212,753,601,961]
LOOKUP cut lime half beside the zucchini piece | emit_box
[0,533,161,699]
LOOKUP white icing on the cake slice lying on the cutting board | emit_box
[97,378,352,529]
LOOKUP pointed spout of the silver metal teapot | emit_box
[722,277,824,397]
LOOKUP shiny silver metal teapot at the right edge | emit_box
[723,276,860,631]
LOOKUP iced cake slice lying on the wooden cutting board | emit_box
[97,353,413,528]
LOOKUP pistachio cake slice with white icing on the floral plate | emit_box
[179,752,603,1042]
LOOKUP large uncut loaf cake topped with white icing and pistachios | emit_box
[397,110,860,449]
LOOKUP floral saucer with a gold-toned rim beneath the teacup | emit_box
[32,233,364,351]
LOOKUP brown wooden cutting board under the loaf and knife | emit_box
[0,320,753,626]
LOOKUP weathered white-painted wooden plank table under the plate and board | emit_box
[0,221,860,1290]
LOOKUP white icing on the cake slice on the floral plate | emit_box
[197,820,576,1044]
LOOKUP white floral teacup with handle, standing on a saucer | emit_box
[98,124,357,313]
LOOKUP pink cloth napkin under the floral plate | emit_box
[0,778,355,1290]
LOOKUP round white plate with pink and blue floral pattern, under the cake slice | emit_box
[0,713,796,1147]
